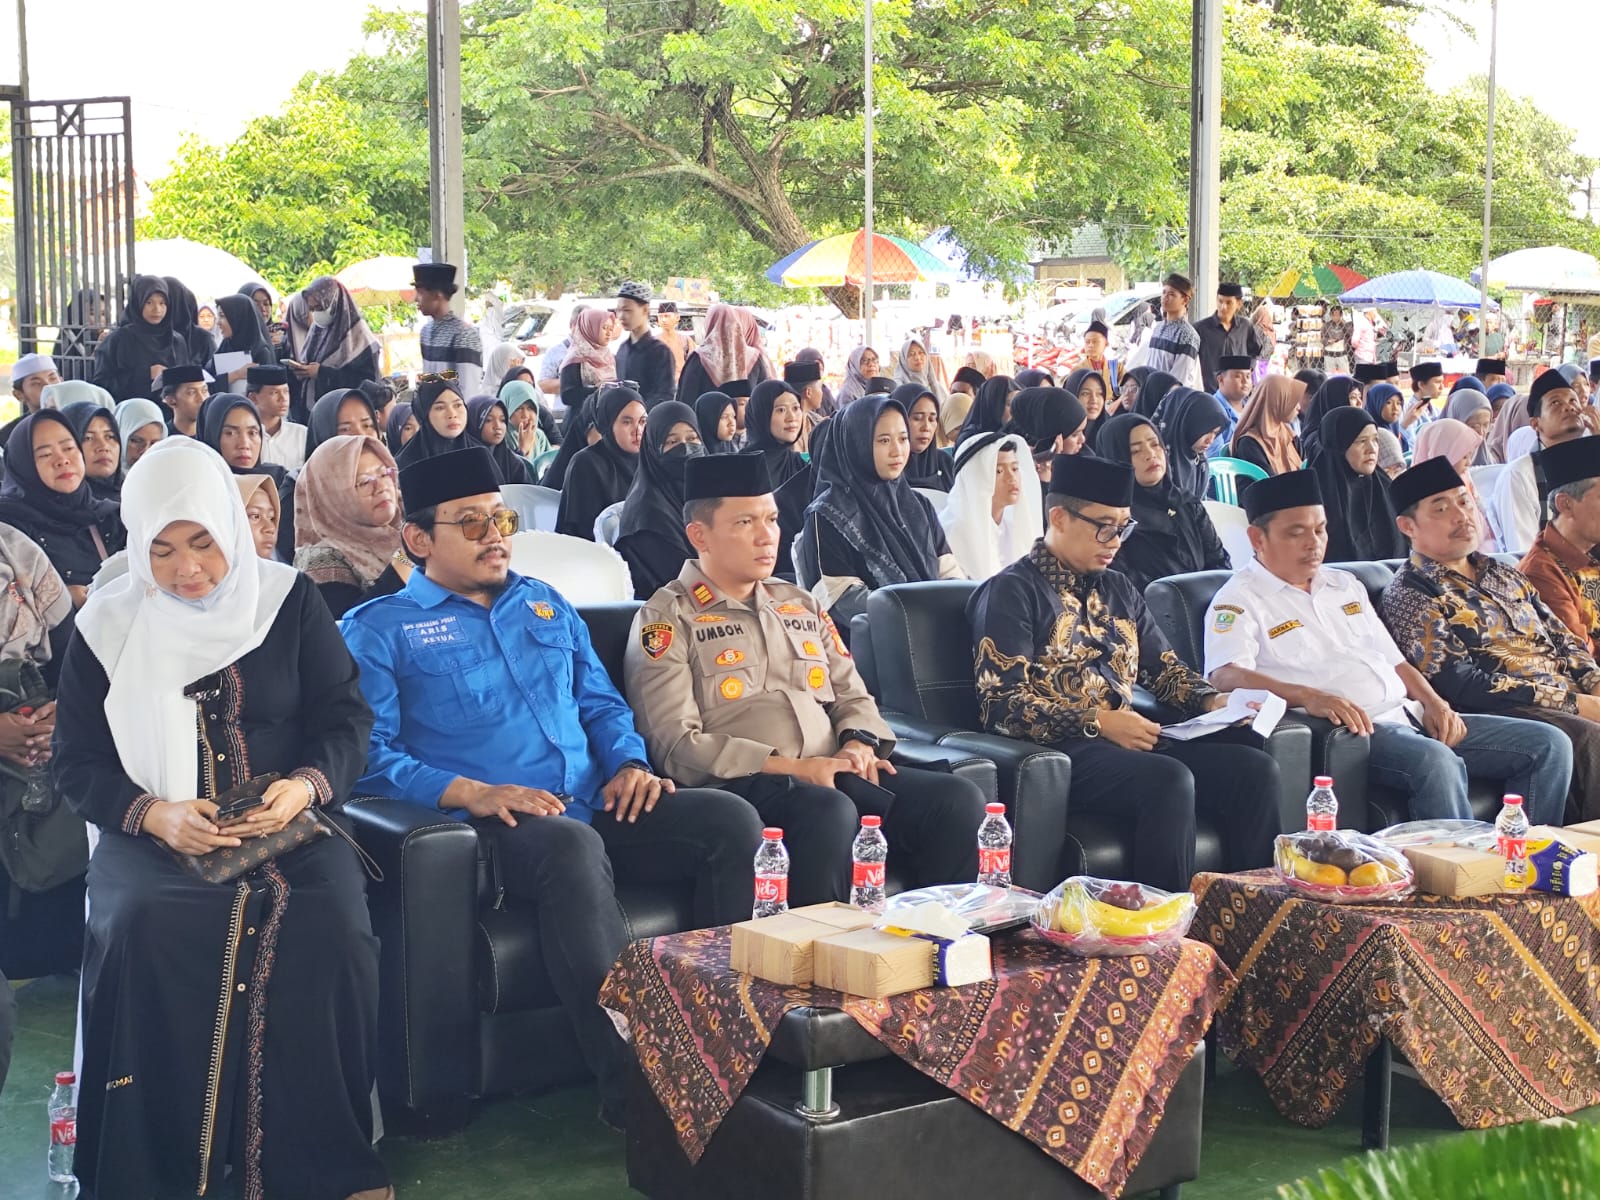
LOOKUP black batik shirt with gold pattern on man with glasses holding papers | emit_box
[966,539,1216,746]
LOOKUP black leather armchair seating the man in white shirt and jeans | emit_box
[1144,563,1504,830]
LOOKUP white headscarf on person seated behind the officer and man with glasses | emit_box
[939,434,1045,579]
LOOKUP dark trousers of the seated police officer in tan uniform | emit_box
[723,766,986,906]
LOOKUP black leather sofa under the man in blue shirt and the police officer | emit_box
[346,603,997,1134]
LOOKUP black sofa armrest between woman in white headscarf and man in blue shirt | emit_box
[344,797,478,1130]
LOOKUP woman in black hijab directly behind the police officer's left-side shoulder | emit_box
[616,397,706,600]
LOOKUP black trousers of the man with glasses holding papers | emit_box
[1061,731,1283,891]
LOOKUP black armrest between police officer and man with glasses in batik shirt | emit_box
[939,730,1072,891]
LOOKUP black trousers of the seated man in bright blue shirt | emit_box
[475,789,762,1107]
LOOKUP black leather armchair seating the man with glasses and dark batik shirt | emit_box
[851,579,1310,890]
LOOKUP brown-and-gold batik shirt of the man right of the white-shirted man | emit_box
[1384,554,1600,712]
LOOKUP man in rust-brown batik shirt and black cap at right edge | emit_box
[1518,437,1600,654]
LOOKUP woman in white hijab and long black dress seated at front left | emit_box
[53,438,392,1200]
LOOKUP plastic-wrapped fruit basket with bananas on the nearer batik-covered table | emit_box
[1034,875,1195,958]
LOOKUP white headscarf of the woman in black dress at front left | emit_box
[78,437,294,800]
